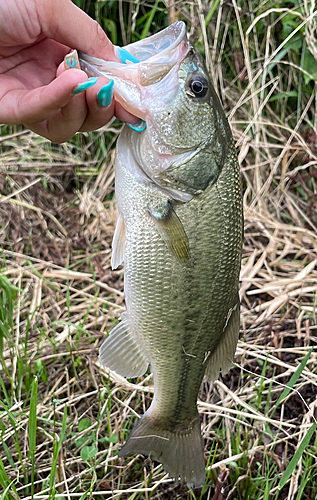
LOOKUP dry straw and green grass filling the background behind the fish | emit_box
[0,0,317,500]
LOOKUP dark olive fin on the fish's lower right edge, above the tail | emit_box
[206,301,240,380]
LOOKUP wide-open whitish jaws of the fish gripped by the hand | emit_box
[79,21,190,120]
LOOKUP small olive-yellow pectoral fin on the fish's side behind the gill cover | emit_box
[149,201,189,262]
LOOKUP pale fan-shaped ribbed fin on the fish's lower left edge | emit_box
[99,313,148,378]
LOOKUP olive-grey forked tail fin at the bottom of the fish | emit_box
[119,408,206,488]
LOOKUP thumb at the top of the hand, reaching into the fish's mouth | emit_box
[37,0,117,61]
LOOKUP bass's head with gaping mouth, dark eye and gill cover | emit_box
[79,21,231,196]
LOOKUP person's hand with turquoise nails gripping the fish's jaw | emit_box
[0,0,138,142]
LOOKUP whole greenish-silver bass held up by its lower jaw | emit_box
[80,21,243,488]
